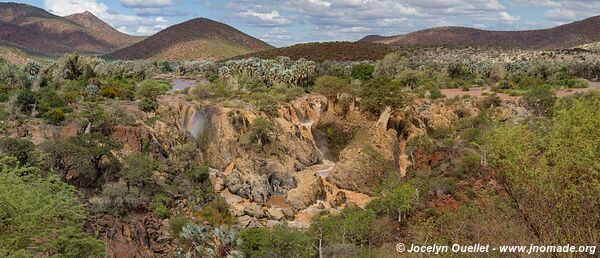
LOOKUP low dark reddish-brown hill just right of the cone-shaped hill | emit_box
[235,42,398,61]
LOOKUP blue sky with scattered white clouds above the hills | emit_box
[8,0,600,47]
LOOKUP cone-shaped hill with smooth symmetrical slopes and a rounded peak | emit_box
[104,18,273,60]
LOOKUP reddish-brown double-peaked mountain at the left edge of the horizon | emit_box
[0,3,141,55]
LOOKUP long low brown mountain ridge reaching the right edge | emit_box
[360,16,600,49]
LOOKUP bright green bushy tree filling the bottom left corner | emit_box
[0,157,104,257]
